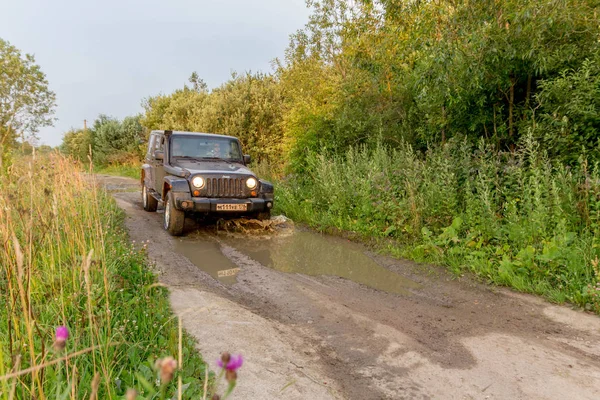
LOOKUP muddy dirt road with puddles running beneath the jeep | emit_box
[99,176,600,399]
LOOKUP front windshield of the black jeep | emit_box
[171,136,242,162]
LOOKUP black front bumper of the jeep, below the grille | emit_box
[174,193,273,214]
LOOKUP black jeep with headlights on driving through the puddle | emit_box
[141,131,273,236]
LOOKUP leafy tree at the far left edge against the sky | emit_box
[0,38,56,173]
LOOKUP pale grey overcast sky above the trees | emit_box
[0,0,309,146]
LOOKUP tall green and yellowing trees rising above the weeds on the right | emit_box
[278,0,600,171]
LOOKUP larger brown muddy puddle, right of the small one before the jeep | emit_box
[224,230,420,295]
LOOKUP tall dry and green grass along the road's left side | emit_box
[0,155,205,399]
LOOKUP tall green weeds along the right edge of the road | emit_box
[275,138,600,312]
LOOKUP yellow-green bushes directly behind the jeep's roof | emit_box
[142,73,283,162]
